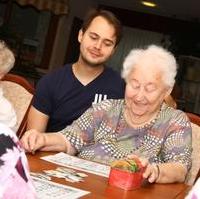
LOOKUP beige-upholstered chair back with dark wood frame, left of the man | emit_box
[1,73,35,138]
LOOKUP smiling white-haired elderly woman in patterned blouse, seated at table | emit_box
[22,45,191,183]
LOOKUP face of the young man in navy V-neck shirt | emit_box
[78,16,116,66]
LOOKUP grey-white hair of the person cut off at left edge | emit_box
[0,41,15,74]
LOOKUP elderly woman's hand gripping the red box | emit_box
[127,155,160,183]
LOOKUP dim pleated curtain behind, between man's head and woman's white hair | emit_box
[107,27,167,71]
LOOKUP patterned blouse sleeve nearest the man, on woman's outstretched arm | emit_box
[61,102,111,152]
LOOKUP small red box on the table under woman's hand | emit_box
[108,168,144,190]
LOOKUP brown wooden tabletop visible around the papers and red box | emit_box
[27,152,190,199]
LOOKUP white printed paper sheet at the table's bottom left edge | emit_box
[32,177,90,199]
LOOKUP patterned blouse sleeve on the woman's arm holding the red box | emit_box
[162,112,192,170]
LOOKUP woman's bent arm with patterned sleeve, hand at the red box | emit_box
[144,111,192,183]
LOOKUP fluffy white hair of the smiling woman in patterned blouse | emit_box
[122,45,177,87]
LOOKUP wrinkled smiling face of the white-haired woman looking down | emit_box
[125,65,169,116]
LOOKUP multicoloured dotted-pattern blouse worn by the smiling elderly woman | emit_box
[61,100,192,169]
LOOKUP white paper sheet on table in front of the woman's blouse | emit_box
[41,152,110,177]
